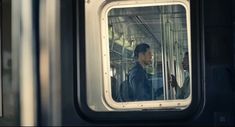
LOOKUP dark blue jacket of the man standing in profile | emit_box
[129,62,152,101]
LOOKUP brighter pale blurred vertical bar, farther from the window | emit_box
[18,0,37,126]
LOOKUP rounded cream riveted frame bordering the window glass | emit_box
[100,0,193,110]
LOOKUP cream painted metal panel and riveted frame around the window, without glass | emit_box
[85,0,191,111]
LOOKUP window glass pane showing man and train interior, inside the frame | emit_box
[108,5,190,102]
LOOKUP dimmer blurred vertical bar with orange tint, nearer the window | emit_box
[39,0,61,126]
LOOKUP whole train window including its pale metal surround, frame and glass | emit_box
[86,0,192,111]
